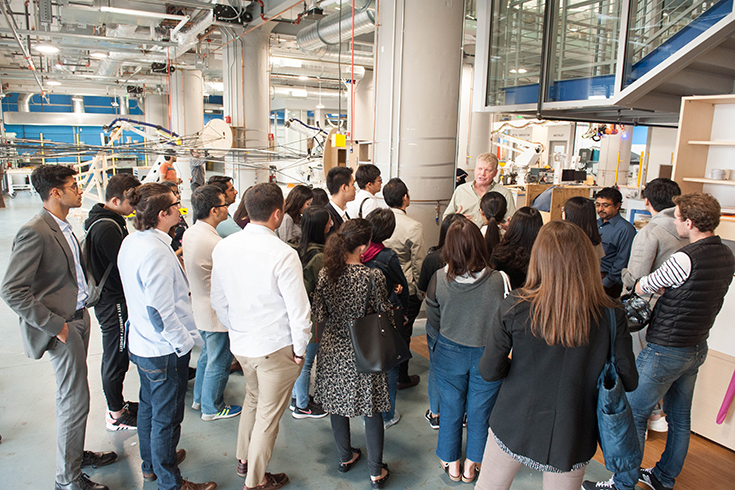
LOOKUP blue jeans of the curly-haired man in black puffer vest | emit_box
[614,342,707,490]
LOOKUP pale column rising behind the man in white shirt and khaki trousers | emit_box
[222,24,272,193]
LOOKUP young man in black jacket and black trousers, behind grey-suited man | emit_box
[84,174,140,431]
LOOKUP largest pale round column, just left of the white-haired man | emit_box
[373,0,464,244]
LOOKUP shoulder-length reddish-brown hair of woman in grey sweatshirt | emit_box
[441,217,489,281]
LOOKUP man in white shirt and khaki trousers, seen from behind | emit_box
[211,183,311,490]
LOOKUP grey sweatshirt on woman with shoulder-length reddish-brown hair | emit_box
[426,269,505,347]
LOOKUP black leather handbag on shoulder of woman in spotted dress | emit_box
[348,270,411,373]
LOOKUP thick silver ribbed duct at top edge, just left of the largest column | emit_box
[296,0,375,51]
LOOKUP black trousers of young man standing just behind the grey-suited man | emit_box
[100,303,130,412]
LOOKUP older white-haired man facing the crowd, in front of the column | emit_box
[444,153,516,226]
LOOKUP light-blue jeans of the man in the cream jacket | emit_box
[194,330,232,415]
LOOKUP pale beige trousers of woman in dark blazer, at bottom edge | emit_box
[475,429,584,490]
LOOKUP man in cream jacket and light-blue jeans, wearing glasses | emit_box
[182,184,242,422]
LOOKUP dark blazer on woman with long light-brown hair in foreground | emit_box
[479,291,638,471]
